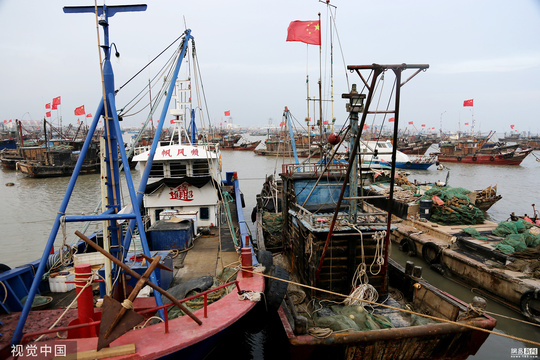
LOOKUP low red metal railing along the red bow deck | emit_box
[21,280,242,344]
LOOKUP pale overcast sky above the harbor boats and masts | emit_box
[0,0,540,136]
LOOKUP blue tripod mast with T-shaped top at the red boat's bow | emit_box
[12,5,165,344]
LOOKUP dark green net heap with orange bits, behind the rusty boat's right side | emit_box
[420,187,485,225]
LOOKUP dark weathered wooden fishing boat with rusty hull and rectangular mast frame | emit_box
[256,64,496,359]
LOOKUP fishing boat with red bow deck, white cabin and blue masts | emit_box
[0,5,265,359]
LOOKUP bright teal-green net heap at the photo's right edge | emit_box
[492,219,540,254]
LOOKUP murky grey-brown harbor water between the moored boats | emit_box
[0,142,540,360]
